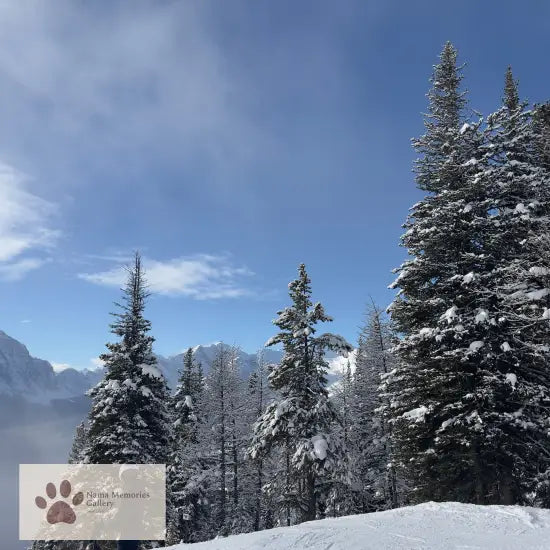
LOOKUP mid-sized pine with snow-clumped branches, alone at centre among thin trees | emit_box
[250,264,352,523]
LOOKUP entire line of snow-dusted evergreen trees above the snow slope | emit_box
[34,43,550,550]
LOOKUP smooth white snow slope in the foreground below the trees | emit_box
[170,502,550,550]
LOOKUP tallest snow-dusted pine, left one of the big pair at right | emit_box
[383,44,490,502]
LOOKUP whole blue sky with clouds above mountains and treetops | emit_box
[0,0,550,368]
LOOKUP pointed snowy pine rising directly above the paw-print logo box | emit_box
[84,253,169,464]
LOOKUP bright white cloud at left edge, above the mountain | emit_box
[0,163,59,281]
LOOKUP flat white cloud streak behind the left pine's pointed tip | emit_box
[79,254,253,300]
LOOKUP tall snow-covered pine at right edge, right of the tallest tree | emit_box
[468,68,550,504]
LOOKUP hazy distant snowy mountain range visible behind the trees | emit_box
[0,331,353,548]
